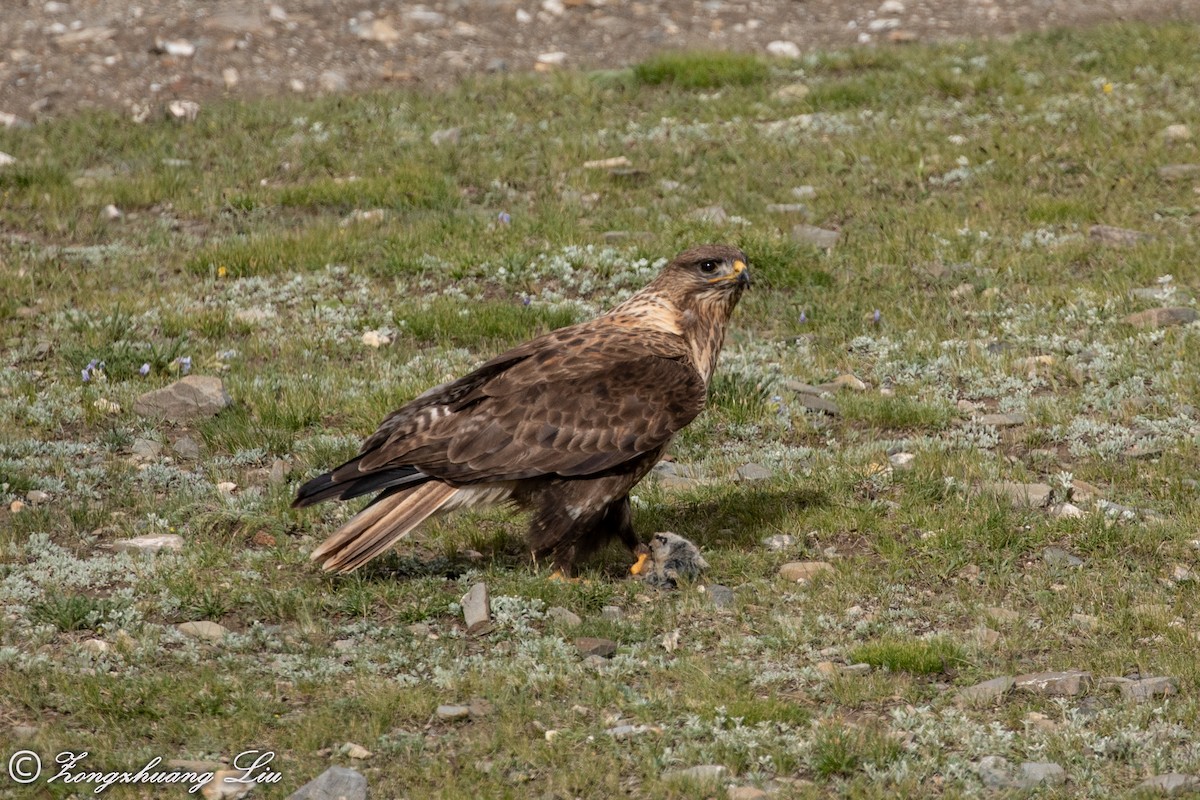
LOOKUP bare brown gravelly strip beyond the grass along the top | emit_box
[0,0,1200,124]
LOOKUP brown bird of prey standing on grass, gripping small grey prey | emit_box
[292,245,750,577]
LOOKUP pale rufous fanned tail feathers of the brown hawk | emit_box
[310,481,462,573]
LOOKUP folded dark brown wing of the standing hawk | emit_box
[347,331,706,483]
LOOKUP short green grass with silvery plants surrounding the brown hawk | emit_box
[0,24,1200,800]
